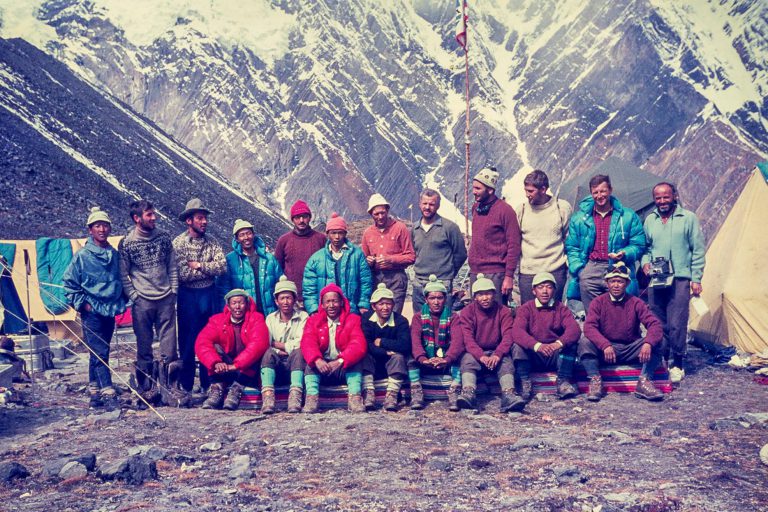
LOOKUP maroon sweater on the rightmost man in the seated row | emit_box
[584,293,664,350]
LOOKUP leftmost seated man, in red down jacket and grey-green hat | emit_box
[195,289,269,410]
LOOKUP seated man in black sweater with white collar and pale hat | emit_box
[362,283,411,411]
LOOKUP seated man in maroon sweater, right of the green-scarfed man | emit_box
[458,273,525,412]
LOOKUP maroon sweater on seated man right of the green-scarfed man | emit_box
[459,301,514,361]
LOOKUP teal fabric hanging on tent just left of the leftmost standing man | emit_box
[35,238,72,315]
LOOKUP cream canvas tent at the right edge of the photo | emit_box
[688,162,768,354]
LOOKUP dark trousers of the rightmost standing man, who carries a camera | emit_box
[648,277,691,357]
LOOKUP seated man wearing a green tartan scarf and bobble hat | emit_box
[408,274,464,411]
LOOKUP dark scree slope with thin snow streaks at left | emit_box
[0,39,286,245]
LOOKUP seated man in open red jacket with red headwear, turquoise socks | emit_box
[301,283,366,413]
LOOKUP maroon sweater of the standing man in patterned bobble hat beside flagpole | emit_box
[469,195,521,277]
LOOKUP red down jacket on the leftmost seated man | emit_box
[195,297,269,377]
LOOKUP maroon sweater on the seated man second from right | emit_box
[512,300,581,350]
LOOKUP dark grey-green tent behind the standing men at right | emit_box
[558,157,662,214]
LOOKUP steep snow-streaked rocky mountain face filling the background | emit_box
[0,0,768,233]
